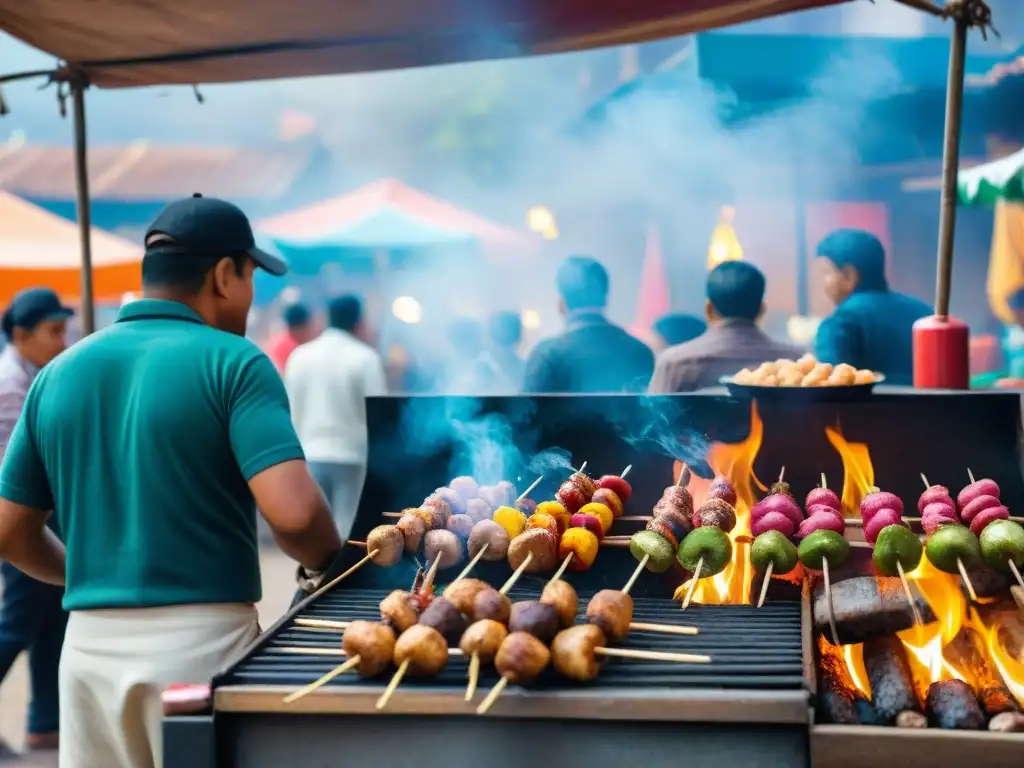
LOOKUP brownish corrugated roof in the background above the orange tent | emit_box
[0,142,311,201]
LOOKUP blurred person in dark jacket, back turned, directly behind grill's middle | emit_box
[522,256,654,392]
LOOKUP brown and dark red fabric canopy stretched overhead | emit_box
[0,0,846,87]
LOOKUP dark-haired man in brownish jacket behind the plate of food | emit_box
[650,261,803,394]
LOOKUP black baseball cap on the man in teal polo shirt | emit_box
[145,193,288,276]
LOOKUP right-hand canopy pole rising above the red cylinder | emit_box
[935,3,970,321]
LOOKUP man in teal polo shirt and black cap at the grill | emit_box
[0,197,350,768]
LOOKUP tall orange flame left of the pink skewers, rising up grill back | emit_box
[671,402,764,605]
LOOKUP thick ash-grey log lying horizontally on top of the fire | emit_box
[814,577,935,651]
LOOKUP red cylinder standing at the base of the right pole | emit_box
[913,314,971,389]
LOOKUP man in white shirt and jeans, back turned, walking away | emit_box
[285,295,387,539]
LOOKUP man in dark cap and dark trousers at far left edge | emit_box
[0,288,75,758]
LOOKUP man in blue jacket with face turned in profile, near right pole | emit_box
[814,229,932,386]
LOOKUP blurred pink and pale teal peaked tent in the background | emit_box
[256,178,524,250]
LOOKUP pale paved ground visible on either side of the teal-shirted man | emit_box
[0,550,295,768]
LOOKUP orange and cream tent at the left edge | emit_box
[0,190,142,306]
